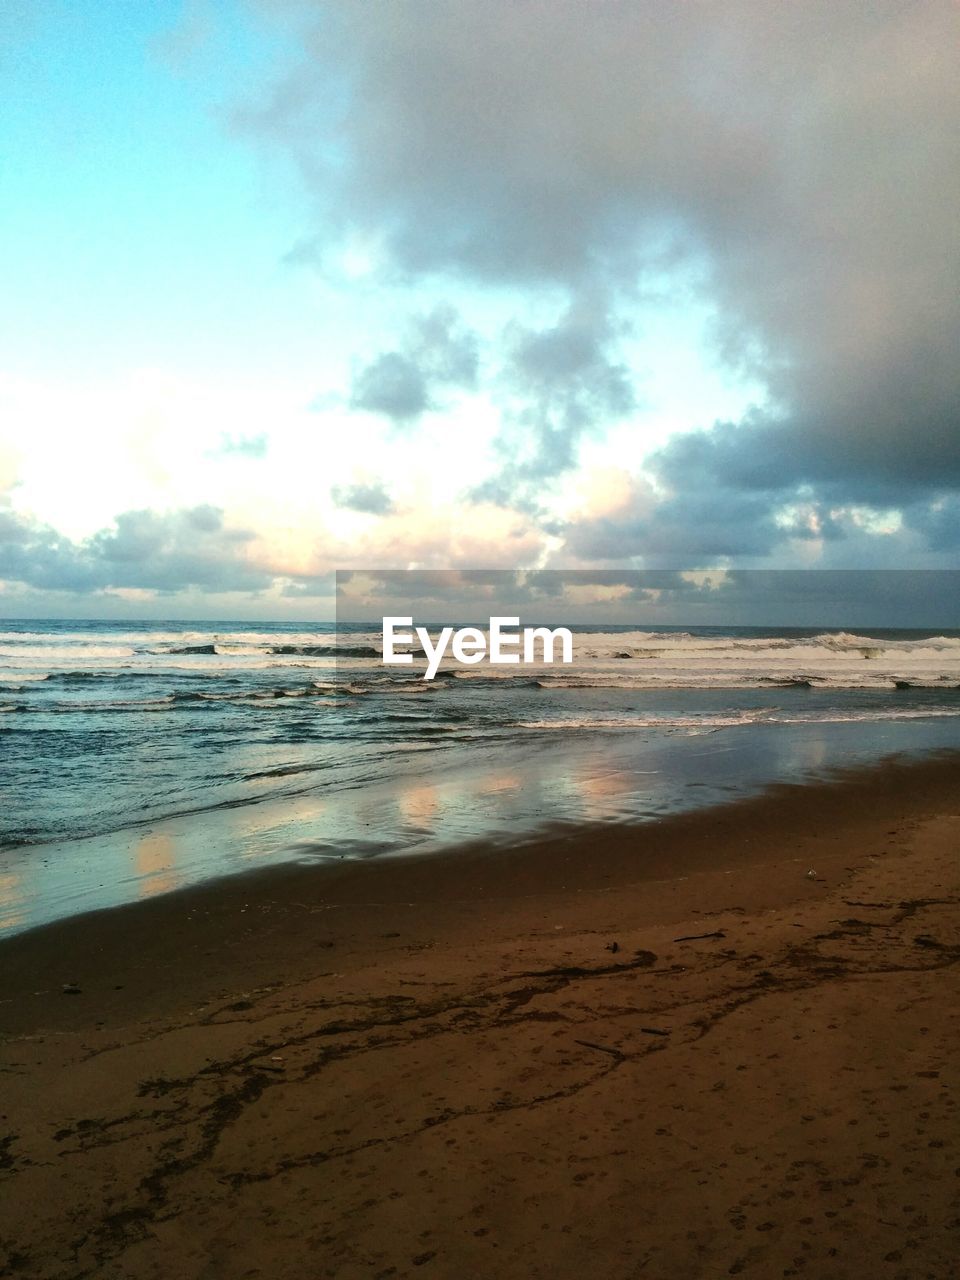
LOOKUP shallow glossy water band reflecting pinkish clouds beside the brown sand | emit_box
[0,721,955,933]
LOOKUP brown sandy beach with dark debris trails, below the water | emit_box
[0,758,960,1280]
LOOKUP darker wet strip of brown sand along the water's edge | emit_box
[0,751,960,1033]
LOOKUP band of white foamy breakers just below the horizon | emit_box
[0,627,960,691]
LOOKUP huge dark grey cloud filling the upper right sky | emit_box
[248,0,960,555]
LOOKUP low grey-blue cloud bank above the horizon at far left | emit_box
[0,506,271,591]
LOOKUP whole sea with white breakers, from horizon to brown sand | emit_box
[0,620,960,933]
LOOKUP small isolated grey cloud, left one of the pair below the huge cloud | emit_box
[349,306,479,425]
